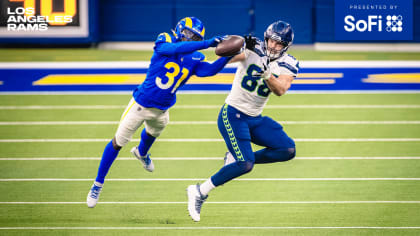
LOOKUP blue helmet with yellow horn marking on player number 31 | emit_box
[174,17,206,41]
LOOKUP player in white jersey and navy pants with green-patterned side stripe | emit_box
[187,21,299,221]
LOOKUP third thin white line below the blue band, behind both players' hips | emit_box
[0,120,420,126]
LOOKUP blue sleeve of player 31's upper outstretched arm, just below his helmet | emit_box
[155,40,208,56]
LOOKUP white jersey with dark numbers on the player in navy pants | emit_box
[225,43,299,116]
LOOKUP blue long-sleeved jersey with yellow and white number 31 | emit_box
[133,33,229,110]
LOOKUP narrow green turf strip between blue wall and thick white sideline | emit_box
[0,47,420,62]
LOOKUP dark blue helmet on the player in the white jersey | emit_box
[264,20,294,60]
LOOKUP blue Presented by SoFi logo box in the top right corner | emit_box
[335,0,413,41]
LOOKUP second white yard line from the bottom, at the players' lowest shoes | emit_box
[0,201,420,205]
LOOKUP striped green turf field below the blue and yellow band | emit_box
[0,94,420,236]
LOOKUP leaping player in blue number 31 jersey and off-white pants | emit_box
[87,17,232,207]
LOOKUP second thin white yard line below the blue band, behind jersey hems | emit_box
[0,104,420,110]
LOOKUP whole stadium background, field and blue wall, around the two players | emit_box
[0,0,420,235]
